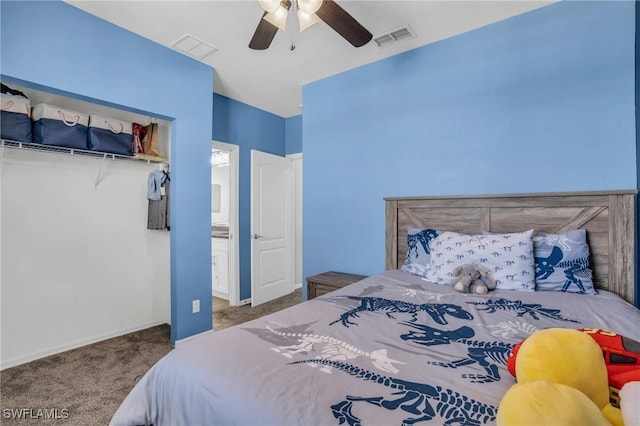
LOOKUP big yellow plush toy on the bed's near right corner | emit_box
[496,328,623,426]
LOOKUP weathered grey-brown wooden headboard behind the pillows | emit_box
[385,190,637,303]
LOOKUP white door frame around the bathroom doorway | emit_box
[211,140,240,306]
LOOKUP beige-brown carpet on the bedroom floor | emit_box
[0,290,301,426]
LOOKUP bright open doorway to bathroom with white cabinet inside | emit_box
[211,141,239,315]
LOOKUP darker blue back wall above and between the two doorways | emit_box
[212,94,285,300]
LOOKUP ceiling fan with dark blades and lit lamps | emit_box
[249,0,373,50]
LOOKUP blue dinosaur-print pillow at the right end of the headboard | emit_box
[533,229,596,294]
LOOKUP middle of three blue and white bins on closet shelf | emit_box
[32,104,89,150]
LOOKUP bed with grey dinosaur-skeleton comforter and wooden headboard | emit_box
[111,191,640,426]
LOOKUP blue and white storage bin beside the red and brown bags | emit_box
[88,115,133,156]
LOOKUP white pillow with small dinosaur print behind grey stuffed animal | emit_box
[426,229,536,291]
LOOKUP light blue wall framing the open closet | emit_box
[0,1,213,342]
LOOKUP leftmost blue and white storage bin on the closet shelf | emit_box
[0,93,32,142]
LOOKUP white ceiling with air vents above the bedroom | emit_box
[66,0,556,117]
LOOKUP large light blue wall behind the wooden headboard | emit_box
[303,2,637,300]
